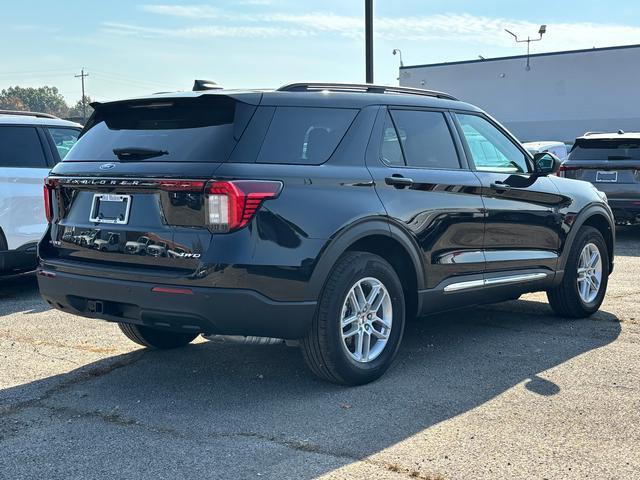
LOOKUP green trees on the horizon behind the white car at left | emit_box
[0,86,69,117]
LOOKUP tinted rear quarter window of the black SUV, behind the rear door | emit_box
[258,107,358,165]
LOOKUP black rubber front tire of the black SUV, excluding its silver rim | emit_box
[547,226,609,318]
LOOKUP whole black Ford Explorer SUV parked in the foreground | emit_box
[38,84,614,384]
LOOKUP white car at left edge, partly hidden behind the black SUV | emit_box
[0,110,81,277]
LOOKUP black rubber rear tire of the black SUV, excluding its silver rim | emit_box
[301,252,405,385]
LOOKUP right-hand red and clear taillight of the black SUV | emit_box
[205,180,282,232]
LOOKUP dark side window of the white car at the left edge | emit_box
[0,126,48,168]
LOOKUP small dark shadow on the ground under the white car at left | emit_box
[0,274,51,317]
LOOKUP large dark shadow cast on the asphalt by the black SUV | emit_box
[0,301,620,478]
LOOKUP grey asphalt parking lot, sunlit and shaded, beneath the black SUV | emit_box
[0,228,640,480]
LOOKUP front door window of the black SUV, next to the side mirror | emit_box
[457,114,529,173]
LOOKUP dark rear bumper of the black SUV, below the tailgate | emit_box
[38,268,316,339]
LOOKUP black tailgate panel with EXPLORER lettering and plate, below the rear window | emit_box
[49,177,212,271]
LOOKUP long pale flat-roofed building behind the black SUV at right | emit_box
[400,45,640,143]
